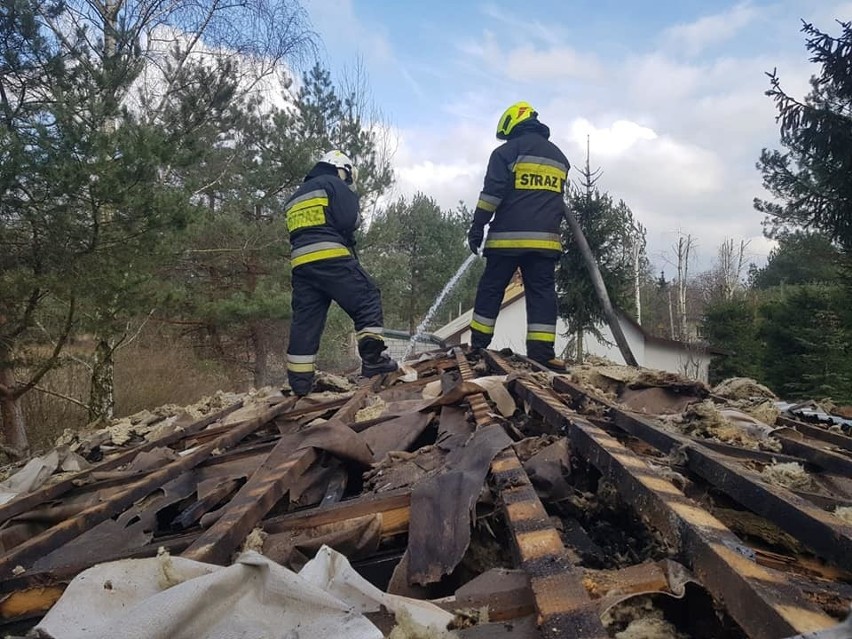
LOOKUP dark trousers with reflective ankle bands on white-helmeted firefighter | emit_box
[287,258,385,395]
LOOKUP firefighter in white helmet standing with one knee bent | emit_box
[285,150,397,395]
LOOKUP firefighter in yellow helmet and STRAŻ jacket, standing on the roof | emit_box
[468,102,571,371]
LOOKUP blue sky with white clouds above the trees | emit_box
[306,0,852,270]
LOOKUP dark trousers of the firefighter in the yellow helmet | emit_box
[470,251,557,362]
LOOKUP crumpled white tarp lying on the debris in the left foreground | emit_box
[36,546,452,639]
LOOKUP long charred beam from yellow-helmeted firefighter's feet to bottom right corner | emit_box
[486,352,833,639]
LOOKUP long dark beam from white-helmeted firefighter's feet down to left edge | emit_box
[0,401,294,579]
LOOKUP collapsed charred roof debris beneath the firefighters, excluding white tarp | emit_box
[0,349,852,639]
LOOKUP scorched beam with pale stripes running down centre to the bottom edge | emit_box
[455,349,607,639]
